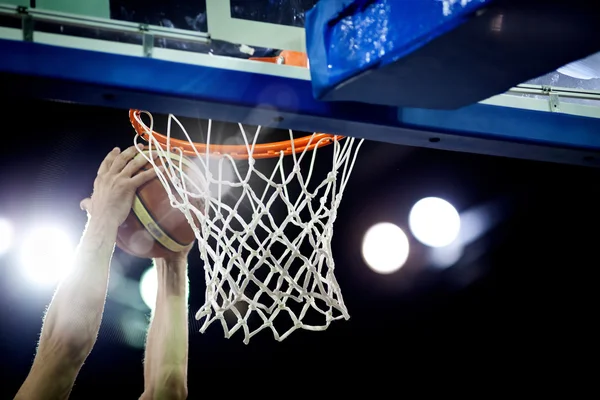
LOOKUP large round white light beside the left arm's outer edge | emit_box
[20,227,75,285]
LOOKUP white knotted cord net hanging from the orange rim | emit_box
[134,113,363,343]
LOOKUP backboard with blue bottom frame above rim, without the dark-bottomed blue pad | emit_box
[0,0,600,166]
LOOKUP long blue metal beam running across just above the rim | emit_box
[0,40,600,166]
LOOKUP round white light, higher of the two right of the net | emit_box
[408,197,460,247]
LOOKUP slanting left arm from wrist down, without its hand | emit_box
[16,220,117,400]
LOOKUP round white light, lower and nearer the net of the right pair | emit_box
[362,222,409,274]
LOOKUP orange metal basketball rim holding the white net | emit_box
[129,110,344,160]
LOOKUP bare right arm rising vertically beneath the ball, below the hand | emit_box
[142,252,188,400]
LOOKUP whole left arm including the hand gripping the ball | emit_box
[15,148,154,400]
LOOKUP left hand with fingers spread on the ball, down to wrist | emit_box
[80,146,156,226]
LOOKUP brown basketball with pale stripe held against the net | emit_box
[117,153,202,258]
